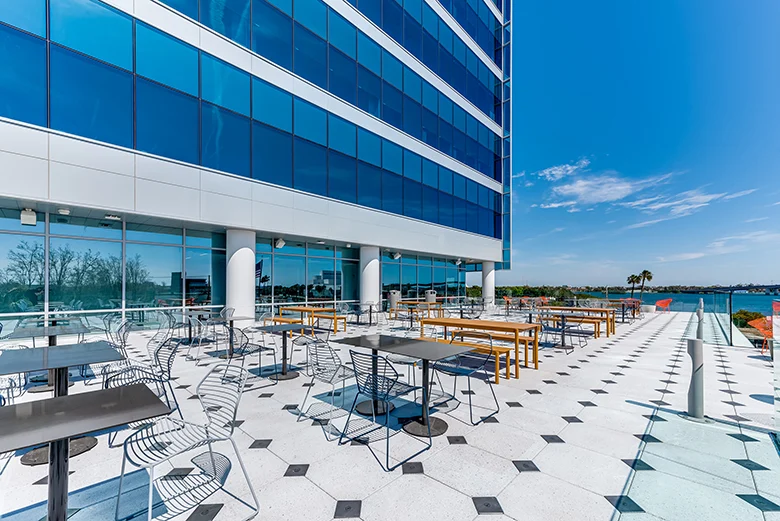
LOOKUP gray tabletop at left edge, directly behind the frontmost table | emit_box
[0,340,122,374]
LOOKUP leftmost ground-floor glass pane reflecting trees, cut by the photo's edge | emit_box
[0,234,45,310]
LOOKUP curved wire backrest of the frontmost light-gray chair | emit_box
[197,364,249,439]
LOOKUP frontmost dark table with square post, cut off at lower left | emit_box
[0,382,170,521]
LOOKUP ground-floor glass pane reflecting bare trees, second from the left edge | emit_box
[49,238,122,311]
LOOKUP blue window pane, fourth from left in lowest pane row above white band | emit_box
[201,103,251,177]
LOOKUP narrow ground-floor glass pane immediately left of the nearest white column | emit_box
[185,248,225,306]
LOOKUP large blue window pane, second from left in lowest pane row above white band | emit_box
[50,45,133,148]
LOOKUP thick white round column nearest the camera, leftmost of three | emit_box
[225,230,255,327]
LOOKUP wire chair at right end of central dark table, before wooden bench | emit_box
[429,332,500,425]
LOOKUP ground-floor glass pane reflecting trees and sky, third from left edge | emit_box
[125,244,182,309]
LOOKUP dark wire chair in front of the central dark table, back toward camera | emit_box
[339,350,433,472]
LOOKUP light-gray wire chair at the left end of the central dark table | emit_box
[297,338,355,441]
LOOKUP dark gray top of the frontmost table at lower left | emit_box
[0,384,170,454]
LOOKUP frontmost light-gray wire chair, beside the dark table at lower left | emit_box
[115,364,260,521]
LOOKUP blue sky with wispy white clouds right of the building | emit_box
[497,0,780,285]
